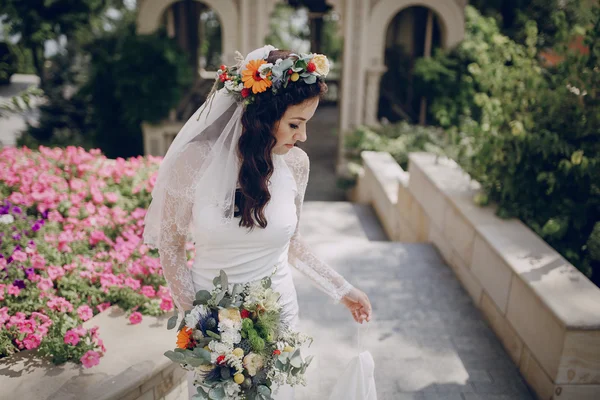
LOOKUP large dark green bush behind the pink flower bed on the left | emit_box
[19,24,192,158]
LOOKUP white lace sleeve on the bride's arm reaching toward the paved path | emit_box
[286,147,353,302]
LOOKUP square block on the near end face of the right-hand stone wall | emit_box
[555,331,600,384]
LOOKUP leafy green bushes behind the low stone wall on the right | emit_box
[416,7,600,283]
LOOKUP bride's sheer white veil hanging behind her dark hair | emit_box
[144,46,276,248]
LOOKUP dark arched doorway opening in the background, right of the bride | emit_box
[377,6,442,123]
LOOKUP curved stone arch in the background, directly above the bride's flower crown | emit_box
[137,0,239,56]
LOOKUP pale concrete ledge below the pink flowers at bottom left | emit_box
[0,307,187,400]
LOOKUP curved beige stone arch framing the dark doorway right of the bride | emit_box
[368,0,465,65]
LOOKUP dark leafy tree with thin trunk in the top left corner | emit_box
[0,0,107,88]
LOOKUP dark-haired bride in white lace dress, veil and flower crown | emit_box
[144,46,371,400]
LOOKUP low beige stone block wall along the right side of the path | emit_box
[355,152,600,400]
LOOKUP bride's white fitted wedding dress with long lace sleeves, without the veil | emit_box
[159,142,352,400]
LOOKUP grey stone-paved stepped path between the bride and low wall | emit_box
[294,201,533,400]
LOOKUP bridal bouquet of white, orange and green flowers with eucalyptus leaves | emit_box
[165,271,312,400]
